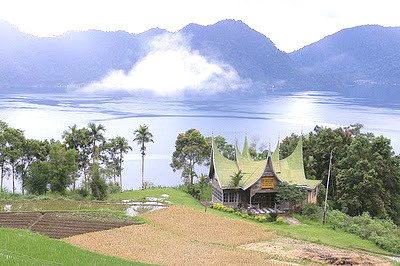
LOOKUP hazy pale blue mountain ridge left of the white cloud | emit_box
[0,22,165,87]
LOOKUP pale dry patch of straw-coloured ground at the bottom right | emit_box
[242,237,390,265]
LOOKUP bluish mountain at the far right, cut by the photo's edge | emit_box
[290,25,400,86]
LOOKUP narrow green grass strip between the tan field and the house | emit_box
[110,188,396,254]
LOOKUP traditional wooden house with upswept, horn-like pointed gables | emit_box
[209,138,321,208]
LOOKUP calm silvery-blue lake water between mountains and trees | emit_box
[0,91,400,192]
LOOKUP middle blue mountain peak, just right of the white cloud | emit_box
[180,20,299,85]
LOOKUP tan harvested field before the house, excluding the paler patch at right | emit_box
[65,206,290,265]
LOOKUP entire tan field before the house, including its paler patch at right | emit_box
[65,206,386,265]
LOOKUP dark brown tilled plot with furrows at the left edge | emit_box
[0,213,133,238]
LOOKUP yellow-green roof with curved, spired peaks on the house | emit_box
[211,138,321,190]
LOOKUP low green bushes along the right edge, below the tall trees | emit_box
[328,210,400,254]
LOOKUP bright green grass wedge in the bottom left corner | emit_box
[0,228,150,265]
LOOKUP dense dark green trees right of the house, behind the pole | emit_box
[280,124,400,224]
